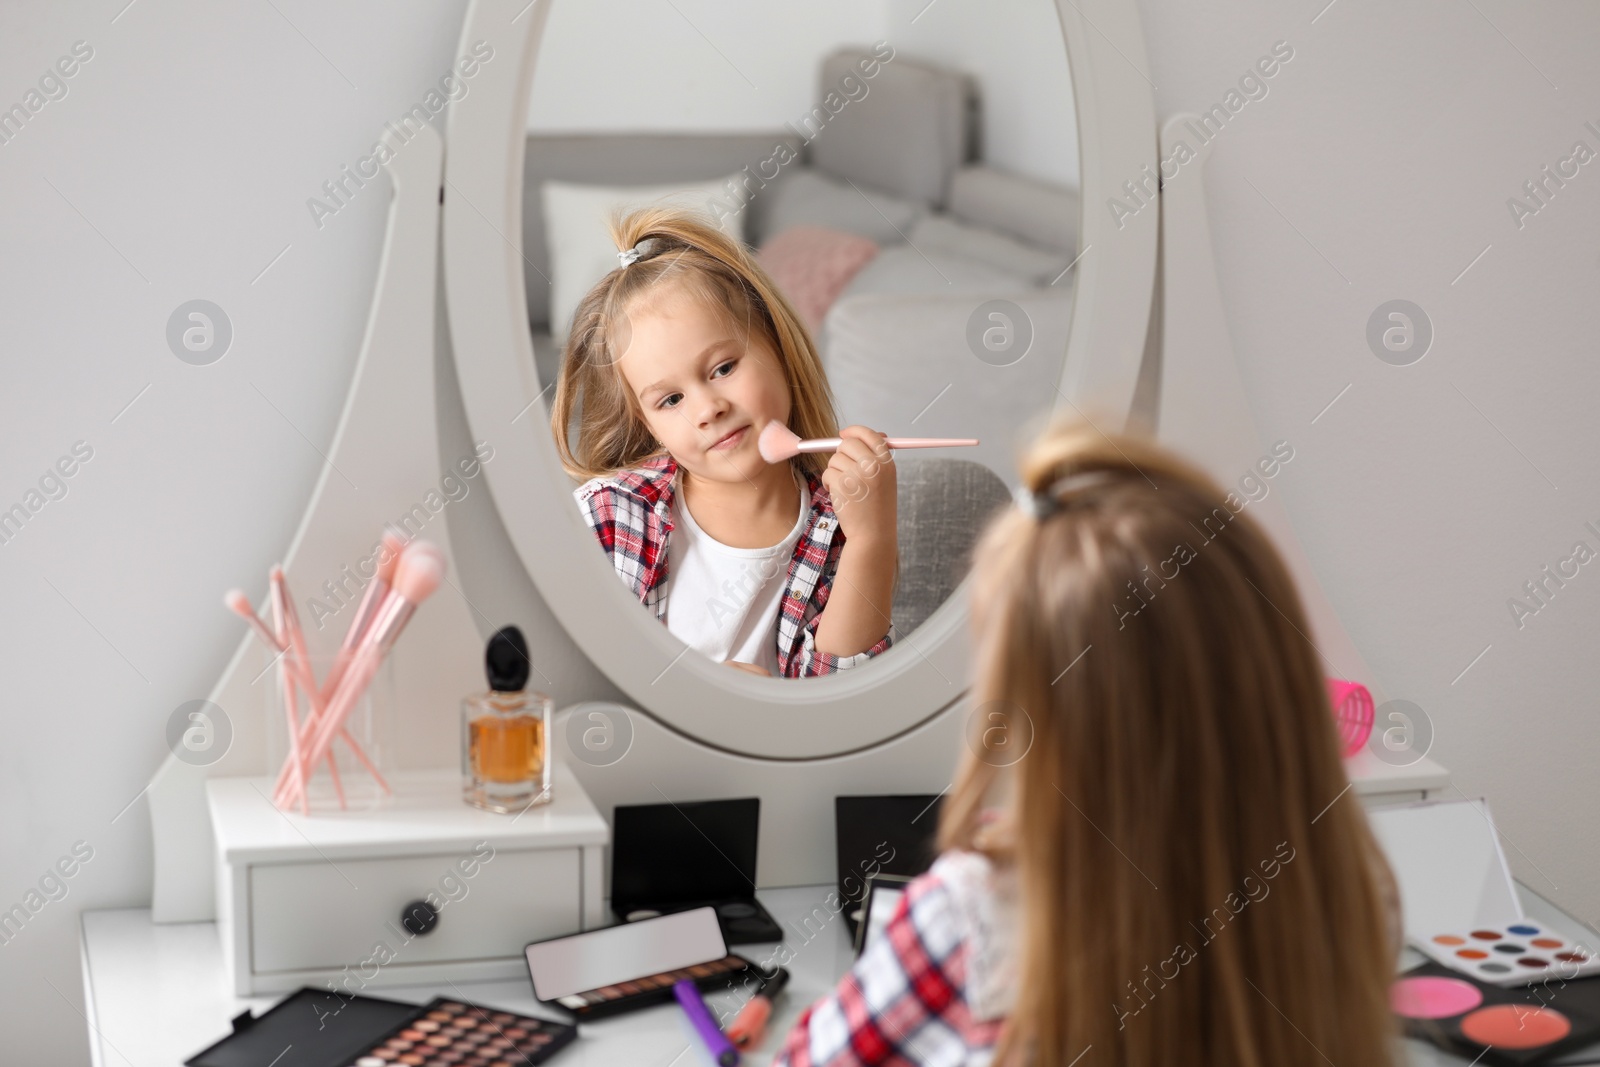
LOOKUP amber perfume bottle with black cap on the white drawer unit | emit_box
[461,625,550,813]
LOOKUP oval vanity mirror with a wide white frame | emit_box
[445,0,1155,758]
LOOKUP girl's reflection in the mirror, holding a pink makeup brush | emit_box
[550,206,899,678]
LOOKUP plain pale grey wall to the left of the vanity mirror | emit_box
[0,0,464,1064]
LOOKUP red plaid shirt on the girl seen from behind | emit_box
[773,853,1014,1067]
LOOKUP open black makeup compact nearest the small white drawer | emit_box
[611,797,784,945]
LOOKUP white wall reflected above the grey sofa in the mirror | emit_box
[528,0,1078,187]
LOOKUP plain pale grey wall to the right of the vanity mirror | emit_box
[1132,0,1600,923]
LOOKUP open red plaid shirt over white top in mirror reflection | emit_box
[573,453,894,678]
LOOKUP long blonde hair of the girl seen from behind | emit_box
[939,424,1395,1067]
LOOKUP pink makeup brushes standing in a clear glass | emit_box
[224,533,445,813]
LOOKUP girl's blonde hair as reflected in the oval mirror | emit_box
[550,206,838,480]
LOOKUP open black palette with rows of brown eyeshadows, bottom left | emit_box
[184,989,578,1067]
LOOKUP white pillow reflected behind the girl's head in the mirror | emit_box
[541,174,744,347]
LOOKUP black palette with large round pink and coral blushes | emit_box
[1389,963,1600,1067]
